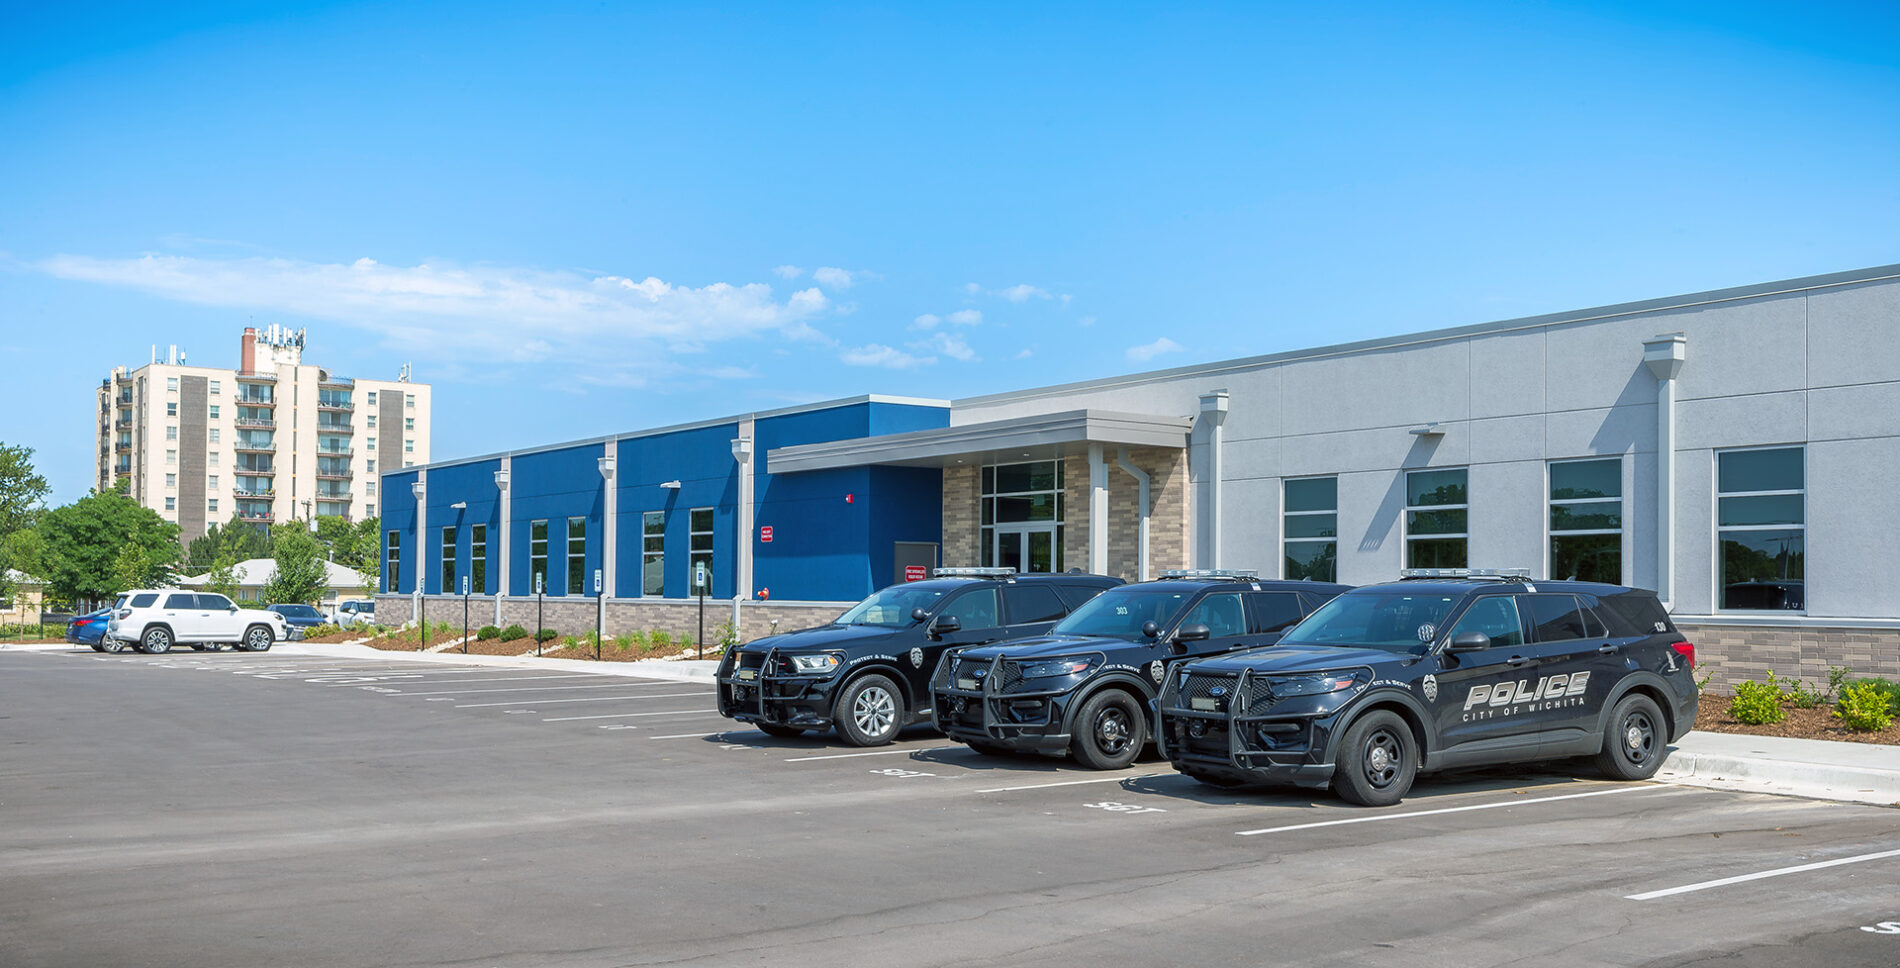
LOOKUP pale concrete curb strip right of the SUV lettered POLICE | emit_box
[1657,732,1900,806]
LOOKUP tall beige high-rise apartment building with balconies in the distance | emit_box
[97,325,429,542]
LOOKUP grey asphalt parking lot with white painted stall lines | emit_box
[0,650,1900,968]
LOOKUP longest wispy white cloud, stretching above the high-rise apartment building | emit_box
[36,255,830,359]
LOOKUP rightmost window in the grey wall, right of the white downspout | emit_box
[1716,447,1807,610]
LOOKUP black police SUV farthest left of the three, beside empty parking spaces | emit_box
[718,569,1121,745]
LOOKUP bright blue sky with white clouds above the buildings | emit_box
[0,2,1900,502]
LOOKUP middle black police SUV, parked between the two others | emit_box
[931,572,1347,770]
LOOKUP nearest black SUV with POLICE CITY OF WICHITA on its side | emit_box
[1157,569,1697,806]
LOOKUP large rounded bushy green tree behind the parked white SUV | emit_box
[38,491,179,601]
